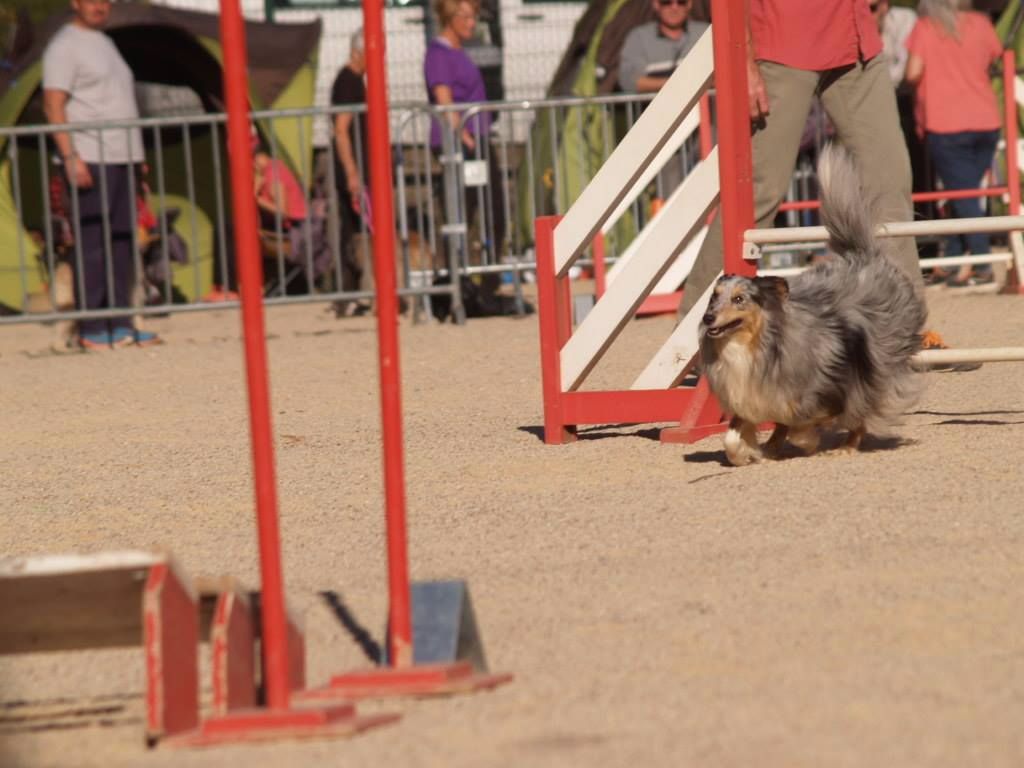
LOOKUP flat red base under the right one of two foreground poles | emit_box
[296,662,512,700]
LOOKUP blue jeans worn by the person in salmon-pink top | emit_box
[928,130,999,271]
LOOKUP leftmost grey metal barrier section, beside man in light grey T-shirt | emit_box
[0,102,453,331]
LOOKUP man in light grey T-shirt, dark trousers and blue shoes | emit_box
[43,0,160,349]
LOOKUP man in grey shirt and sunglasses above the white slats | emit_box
[618,0,708,93]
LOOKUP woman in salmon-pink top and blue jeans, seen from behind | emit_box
[906,0,1002,287]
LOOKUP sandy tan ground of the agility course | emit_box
[0,292,1024,768]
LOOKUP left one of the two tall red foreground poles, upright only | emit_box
[220,0,289,709]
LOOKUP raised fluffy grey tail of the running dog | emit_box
[818,143,879,261]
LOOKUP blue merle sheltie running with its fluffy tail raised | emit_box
[699,145,927,466]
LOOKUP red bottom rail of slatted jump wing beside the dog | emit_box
[559,387,693,424]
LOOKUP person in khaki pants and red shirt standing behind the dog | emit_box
[679,0,923,317]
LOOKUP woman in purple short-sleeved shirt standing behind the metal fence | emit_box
[423,0,505,260]
